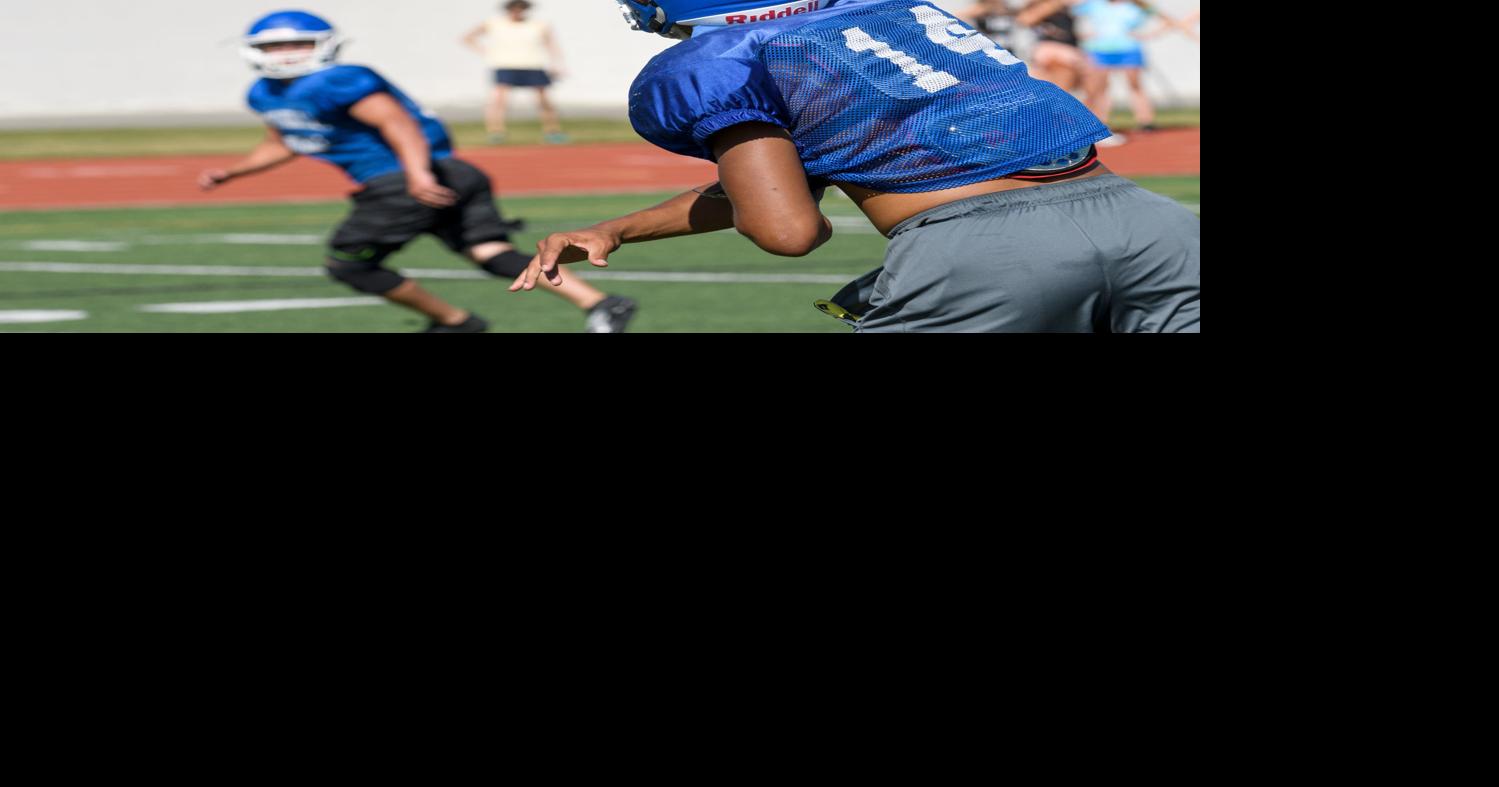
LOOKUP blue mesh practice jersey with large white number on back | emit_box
[630,0,1109,193]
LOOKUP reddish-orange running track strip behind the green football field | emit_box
[0,129,1202,210]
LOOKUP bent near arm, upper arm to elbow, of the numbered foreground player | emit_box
[712,123,833,256]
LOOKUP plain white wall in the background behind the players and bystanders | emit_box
[0,0,1201,127]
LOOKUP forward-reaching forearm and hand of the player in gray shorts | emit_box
[510,183,735,292]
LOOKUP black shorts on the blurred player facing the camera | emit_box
[330,159,510,259]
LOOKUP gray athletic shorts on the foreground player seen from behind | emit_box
[833,175,1202,333]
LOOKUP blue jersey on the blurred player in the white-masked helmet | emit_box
[249,66,453,183]
